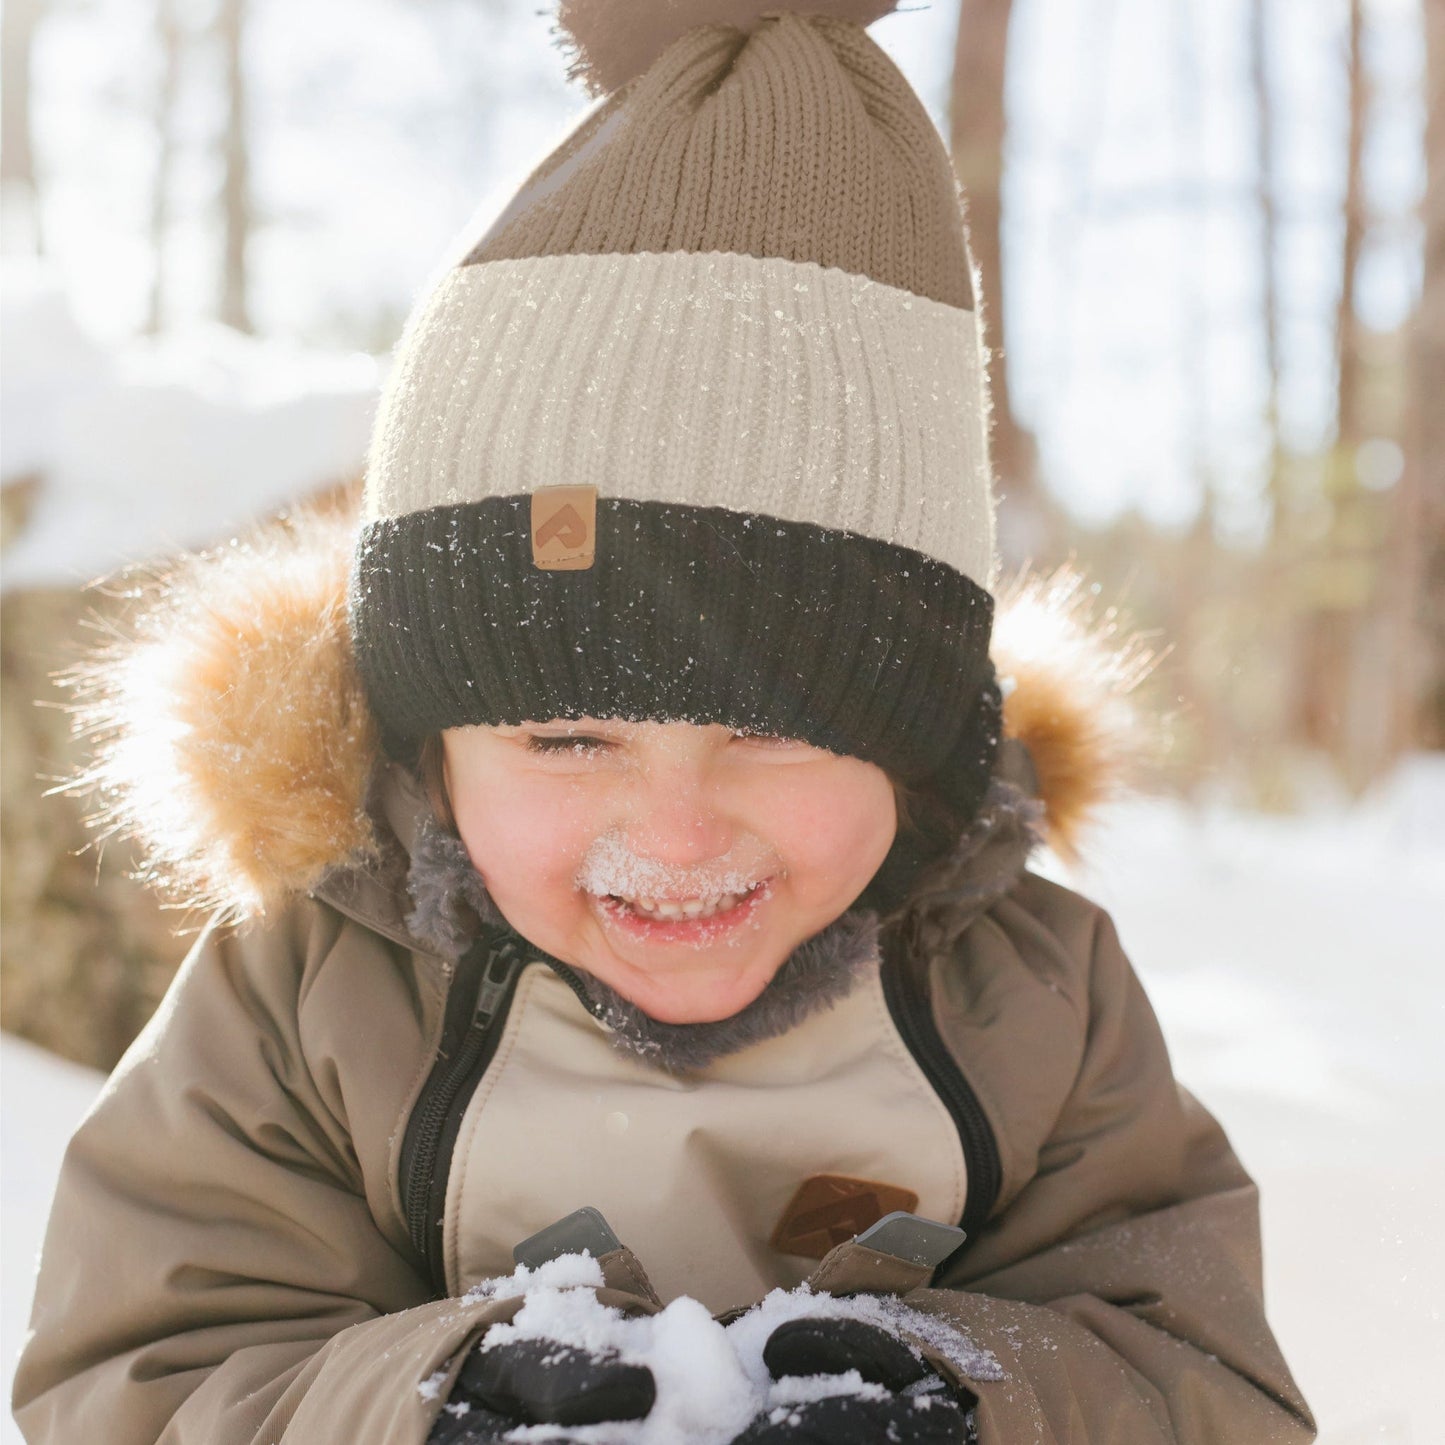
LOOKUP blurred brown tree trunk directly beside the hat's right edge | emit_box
[948,0,1059,564]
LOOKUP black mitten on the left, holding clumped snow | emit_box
[428,1340,657,1445]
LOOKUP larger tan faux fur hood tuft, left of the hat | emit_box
[61,510,380,922]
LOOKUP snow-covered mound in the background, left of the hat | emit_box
[0,262,380,588]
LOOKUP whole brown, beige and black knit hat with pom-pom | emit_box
[350,0,998,843]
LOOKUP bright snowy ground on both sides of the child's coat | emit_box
[0,780,1445,1445]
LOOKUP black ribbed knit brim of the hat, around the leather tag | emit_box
[351,496,997,806]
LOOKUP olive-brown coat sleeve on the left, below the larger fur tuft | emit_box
[13,903,517,1445]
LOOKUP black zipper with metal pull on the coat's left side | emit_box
[399,929,523,1298]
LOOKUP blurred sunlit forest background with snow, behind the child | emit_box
[0,0,1445,1066]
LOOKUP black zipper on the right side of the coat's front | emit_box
[881,929,1003,1247]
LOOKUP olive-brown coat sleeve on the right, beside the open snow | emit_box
[909,909,1315,1445]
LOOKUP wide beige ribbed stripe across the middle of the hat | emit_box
[367,251,994,585]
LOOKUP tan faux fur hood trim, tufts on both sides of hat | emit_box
[66,509,1152,922]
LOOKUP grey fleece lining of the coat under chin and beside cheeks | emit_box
[406,777,1043,1074]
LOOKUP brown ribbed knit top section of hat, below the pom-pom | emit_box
[462,13,972,308]
